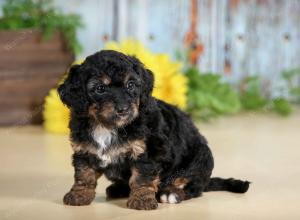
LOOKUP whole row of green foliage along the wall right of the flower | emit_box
[185,67,300,120]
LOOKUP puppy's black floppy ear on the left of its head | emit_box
[57,65,88,112]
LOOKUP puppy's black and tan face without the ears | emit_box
[86,71,141,127]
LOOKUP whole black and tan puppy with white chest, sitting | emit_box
[58,50,249,210]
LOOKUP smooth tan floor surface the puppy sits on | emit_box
[0,112,300,220]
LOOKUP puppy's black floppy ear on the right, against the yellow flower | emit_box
[130,56,154,102]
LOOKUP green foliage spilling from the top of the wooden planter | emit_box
[0,0,83,54]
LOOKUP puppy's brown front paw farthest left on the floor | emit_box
[63,190,95,206]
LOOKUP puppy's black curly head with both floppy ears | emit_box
[58,50,154,128]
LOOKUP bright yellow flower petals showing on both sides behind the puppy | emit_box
[43,39,188,134]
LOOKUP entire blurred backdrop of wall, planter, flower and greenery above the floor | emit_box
[0,0,300,133]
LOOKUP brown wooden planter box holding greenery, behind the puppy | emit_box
[0,30,74,126]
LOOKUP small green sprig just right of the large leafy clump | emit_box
[240,76,268,110]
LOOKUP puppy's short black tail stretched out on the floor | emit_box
[204,177,250,193]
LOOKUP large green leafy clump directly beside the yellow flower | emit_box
[185,67,240,119]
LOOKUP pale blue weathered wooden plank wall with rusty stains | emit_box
[1,0,300,89]
